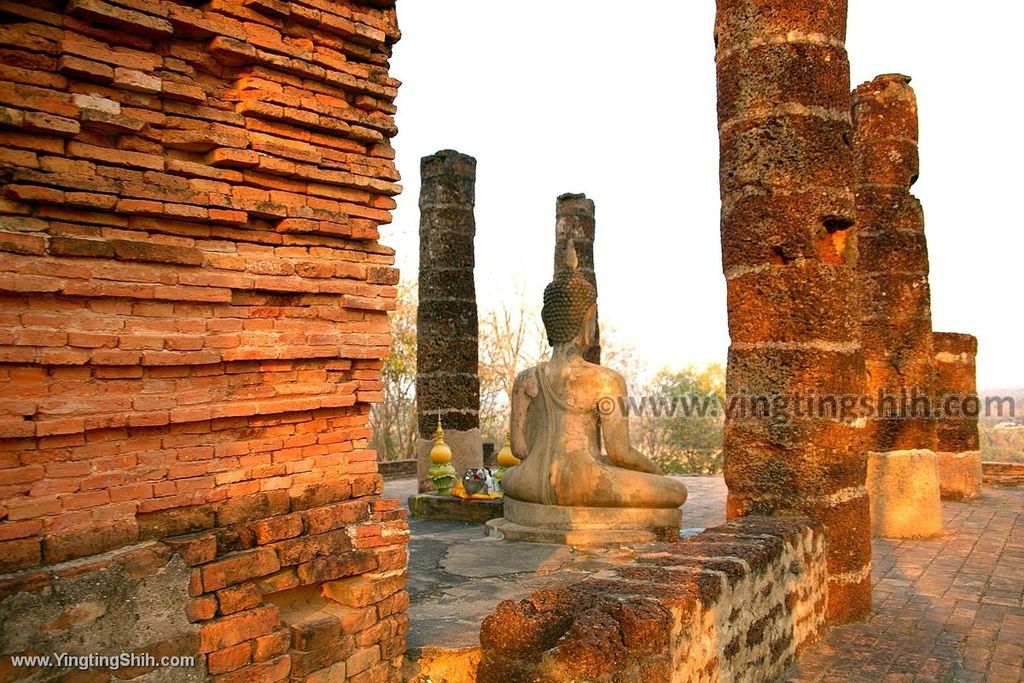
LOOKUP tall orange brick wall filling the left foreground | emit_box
[0,0,408,681]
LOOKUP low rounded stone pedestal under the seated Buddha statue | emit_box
[487,497,683,546]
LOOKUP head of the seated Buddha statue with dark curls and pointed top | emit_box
[541,241,597,349]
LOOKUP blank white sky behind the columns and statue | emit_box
[383,0,1024,389]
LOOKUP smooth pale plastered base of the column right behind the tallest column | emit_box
[867,450,942,539]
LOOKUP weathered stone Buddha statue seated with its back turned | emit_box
[502,244,686,524]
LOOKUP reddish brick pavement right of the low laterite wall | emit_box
[785,487,1024,683]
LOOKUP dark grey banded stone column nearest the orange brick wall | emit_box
[416,150,483,493]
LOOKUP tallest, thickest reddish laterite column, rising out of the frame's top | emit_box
[715,0,871,623]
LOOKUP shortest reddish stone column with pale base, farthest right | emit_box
[932,332,981,500]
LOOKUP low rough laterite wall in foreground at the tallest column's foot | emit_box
[477,517,827,683]
